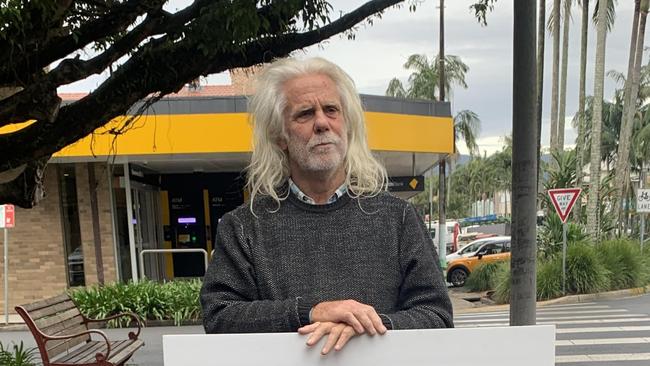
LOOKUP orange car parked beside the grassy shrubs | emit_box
[447,238,510,287]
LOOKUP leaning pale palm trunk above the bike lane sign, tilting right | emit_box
[614,0,648,227]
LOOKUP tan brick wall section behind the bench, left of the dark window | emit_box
[0,165,67,313]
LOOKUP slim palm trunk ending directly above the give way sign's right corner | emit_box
[576,0,589,187]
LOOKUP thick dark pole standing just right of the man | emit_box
[510,0,536,326]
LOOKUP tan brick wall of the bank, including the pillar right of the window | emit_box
[0,163,117,313]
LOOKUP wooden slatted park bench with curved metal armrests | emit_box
[15,294,144,366]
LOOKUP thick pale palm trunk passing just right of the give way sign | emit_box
[587,0,608,241]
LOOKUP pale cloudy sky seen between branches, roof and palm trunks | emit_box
[60,0,636,155]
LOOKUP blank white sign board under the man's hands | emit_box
[163,325,555,366]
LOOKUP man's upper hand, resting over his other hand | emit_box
[311,300,386,335]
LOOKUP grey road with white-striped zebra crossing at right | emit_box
[455,294,650,366]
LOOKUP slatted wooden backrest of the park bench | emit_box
[16,294,90,363]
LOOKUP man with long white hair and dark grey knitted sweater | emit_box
[201,58,453,354]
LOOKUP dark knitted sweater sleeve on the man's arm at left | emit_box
[201,214,311,333]
